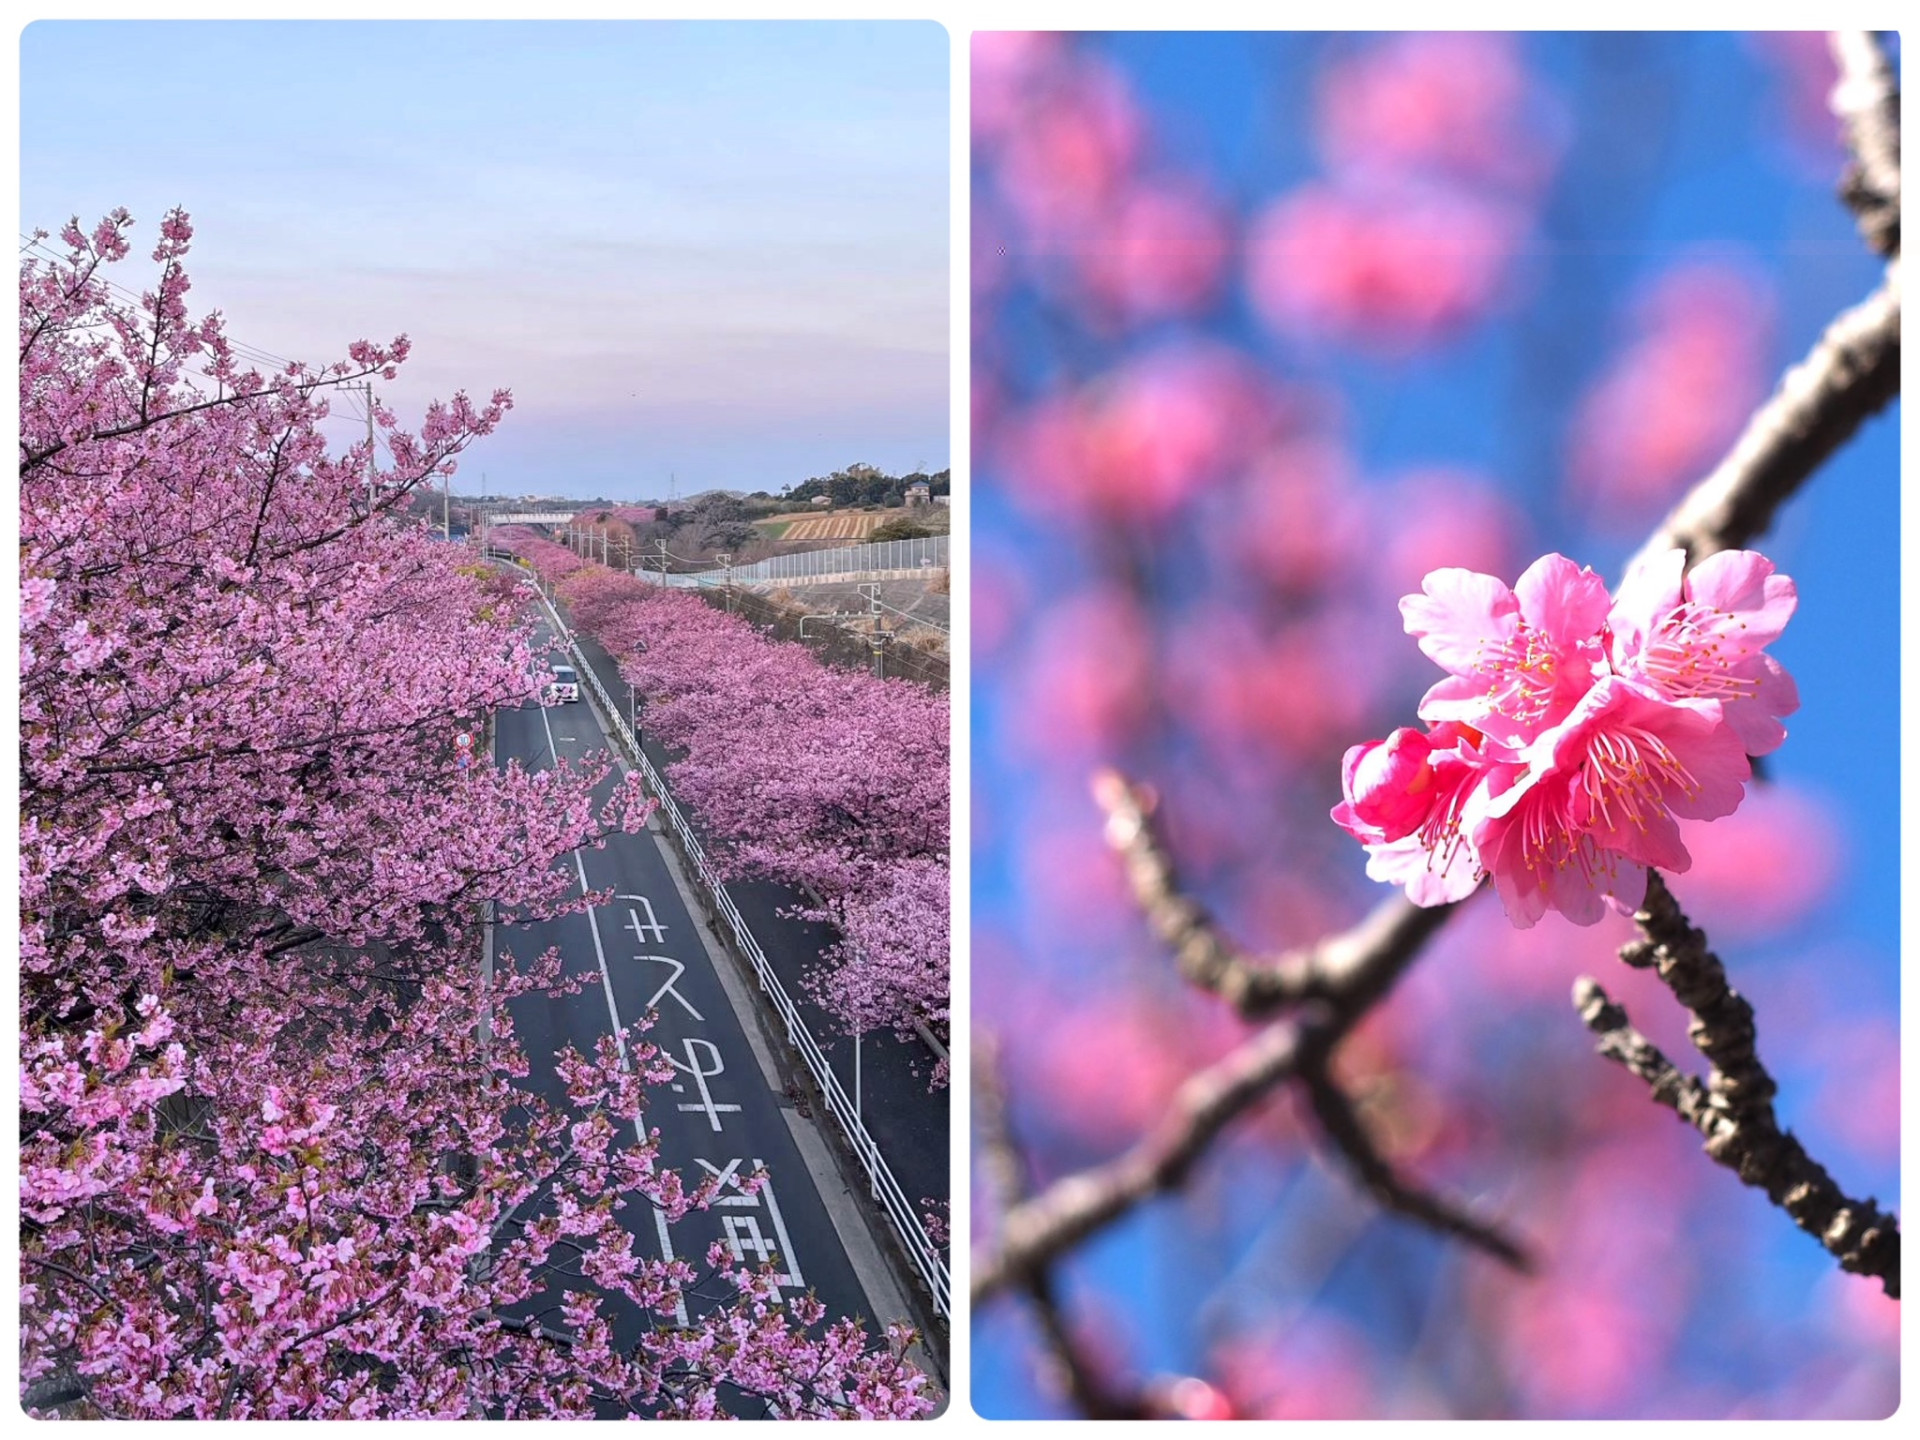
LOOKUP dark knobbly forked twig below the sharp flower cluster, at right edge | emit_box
[1574,870,1901,1300]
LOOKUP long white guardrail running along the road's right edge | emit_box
[536,586,952,1319]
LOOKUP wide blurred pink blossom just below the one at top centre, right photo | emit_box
[1246,182,1526,355]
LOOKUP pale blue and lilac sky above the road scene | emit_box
[21,21,948,499]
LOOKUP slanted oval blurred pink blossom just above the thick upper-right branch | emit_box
[1569,259,1772,532]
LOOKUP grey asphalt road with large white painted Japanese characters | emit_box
[480,622,908,1420]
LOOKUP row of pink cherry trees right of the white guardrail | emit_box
[495,526,948,1052]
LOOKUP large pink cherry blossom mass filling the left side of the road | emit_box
[21,211,929,1419]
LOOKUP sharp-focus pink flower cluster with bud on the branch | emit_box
[1332,549,1799,927]
